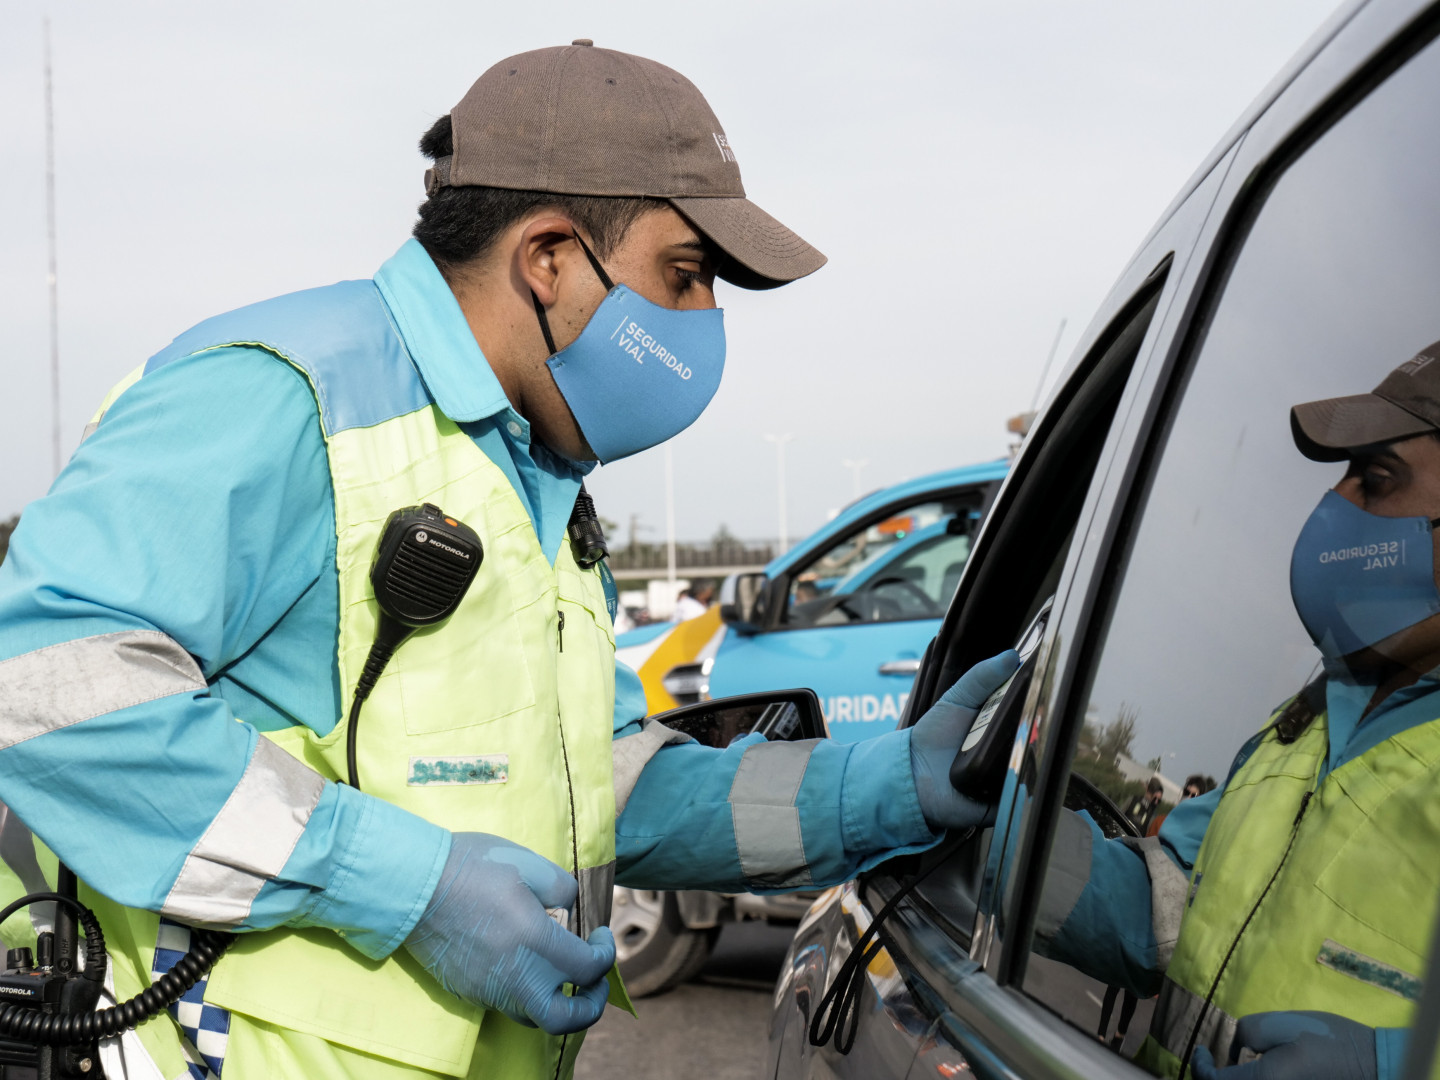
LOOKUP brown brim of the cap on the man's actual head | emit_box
[670,197,827,289]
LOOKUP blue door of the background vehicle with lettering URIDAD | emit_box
[708,467,1004,742]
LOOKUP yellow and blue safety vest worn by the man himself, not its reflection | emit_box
[67,282,622,1080]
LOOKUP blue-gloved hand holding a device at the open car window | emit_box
[910,649,1020,829]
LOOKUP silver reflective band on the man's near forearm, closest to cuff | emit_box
[160,736,325,926]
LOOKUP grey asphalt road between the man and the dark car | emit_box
[575,923,793,1080]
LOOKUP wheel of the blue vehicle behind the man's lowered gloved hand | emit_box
[611,886,720,998]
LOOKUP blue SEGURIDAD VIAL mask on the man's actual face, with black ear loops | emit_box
[534,233,724,462]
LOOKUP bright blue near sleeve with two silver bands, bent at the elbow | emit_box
[0,348,449,958]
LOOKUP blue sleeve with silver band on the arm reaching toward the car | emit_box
[615,667,940,893]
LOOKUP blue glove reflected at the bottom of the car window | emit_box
[1189,1012,1380,1080]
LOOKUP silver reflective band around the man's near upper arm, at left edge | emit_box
[0,631,204,750]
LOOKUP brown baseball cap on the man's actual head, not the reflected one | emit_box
[425,37,825,289]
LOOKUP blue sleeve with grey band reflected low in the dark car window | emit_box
[1035,789,1221,996]
